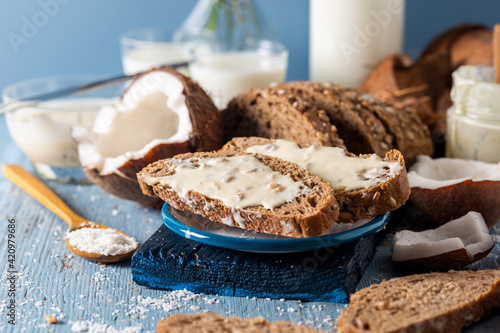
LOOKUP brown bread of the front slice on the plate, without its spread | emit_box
[137,152,339,237]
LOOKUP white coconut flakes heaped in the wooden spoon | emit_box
[66,228,138,256]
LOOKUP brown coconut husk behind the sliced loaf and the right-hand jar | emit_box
[361,24,493,156]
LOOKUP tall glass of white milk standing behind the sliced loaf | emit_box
[309,0,405,88]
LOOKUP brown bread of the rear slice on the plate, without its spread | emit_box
[220,137,410,223]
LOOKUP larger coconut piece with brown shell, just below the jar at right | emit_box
[408,155,500,227]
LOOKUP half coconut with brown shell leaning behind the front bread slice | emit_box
[72,68,223,205]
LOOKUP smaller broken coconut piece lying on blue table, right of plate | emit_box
[392,212,495,269]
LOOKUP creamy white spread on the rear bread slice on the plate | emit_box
[247,140,402,191]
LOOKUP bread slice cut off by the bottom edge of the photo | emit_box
[156,313,326,333]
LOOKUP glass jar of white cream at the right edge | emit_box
[446,66,500,163]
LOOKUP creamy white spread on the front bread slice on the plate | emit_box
[141,155,310,209]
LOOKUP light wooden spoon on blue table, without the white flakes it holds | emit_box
[2,165,138,262]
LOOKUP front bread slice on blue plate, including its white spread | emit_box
[137,151,339,237]
